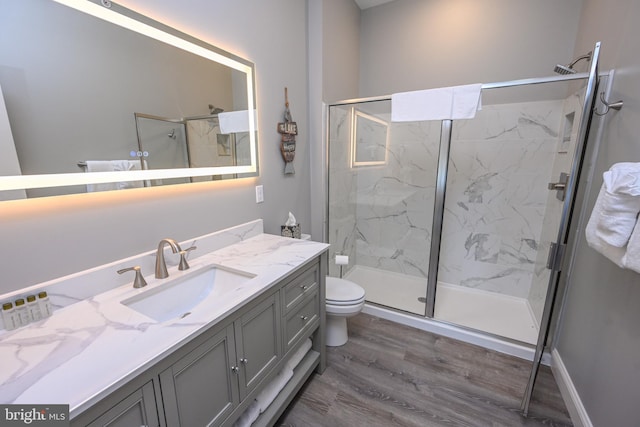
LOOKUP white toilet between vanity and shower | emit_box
[326,276,364,347]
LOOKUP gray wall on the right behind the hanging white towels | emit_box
[556,0,640,426]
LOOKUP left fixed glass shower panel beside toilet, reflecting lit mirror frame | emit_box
[328,99,441,316]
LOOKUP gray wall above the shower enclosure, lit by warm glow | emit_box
[360,0,582,97]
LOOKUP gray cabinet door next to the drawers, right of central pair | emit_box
[235,293,282,399]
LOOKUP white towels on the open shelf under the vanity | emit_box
[234,338,312,427]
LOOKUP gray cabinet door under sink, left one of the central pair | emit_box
[160,326,239,427]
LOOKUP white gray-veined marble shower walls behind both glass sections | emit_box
[329,97,568,312]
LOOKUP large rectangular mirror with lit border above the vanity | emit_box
[0,0,258,200]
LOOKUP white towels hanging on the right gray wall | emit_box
[586,162,640,273]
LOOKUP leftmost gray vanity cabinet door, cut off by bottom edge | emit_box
[88,382,159,427]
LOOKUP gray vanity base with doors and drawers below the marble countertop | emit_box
[71,254,326,427]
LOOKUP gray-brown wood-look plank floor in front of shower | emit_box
[276,314,572,427]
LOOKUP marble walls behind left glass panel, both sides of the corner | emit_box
[329,101,441,278]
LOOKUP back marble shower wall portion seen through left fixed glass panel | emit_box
[355,116,441,278]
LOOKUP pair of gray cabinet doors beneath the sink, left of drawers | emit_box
[160,293,281,427]
